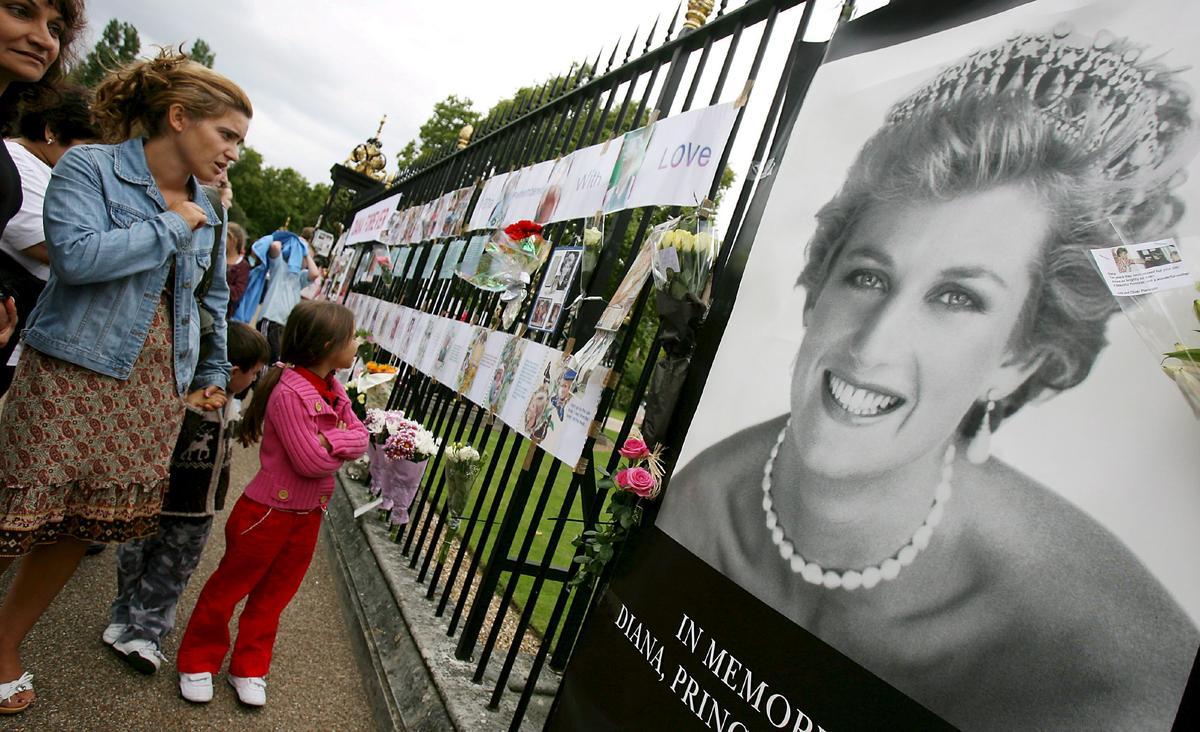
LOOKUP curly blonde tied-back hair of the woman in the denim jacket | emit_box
[92,48,254,143]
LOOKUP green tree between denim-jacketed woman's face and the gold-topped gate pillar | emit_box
[229,148,329,238]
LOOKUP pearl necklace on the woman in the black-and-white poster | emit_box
[762,420,954,590]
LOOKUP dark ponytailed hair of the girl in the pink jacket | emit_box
[238,300,354,446]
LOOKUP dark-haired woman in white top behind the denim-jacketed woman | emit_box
[0,86,97,396]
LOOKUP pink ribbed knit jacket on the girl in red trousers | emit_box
[246,368,370,511]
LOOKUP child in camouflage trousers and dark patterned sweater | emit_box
[102,322,270,673]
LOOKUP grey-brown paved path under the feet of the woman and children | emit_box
[0,441,374,732]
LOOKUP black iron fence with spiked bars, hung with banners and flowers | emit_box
[328,0,812,730]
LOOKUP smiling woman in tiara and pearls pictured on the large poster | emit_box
[658,25,1200,730]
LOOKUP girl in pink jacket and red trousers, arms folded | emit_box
[176,300,368,707]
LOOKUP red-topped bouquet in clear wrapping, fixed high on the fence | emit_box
[463,221,551,328]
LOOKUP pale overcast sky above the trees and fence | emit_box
[87,0,720,182]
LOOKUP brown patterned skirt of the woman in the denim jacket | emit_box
[0,299,185,557]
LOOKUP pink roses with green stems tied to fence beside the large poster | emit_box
[570,436,662,587]
